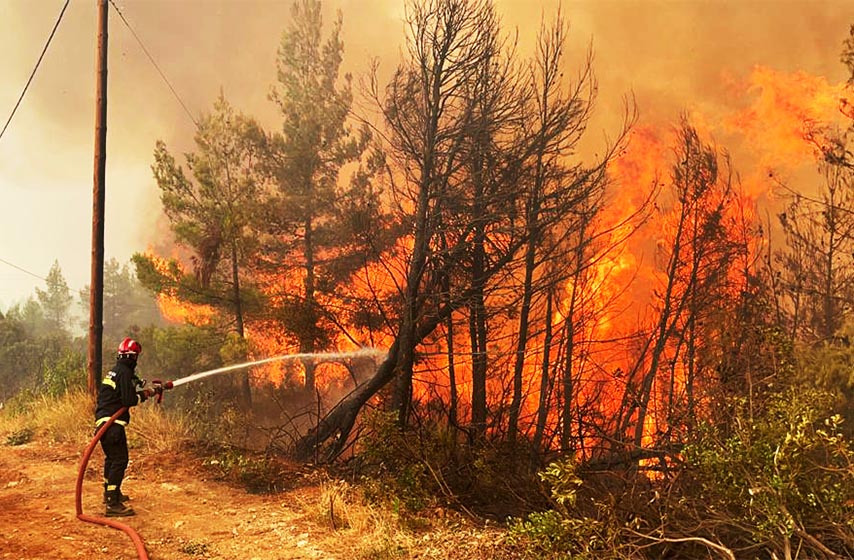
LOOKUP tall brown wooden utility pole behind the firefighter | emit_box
[87,0,109,395]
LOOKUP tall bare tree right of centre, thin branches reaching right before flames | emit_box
[507,13,646,450]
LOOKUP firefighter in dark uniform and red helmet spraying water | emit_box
[95,338,158,517]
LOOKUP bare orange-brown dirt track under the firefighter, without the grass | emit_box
[0,443,382,560]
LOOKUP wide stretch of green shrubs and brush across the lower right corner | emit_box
[510,386,854,558]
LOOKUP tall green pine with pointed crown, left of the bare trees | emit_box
[254,0,386,392]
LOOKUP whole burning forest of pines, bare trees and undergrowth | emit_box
[0,0,854,560]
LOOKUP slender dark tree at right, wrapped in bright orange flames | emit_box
[616,121,752,456]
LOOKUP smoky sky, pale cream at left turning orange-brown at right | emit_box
[0,0,854,311]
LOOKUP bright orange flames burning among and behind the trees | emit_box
[144,62,850,445]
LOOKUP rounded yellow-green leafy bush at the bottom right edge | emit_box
[684,388,854,554]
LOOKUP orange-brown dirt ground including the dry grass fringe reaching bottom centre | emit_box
[0,440,516,560]
